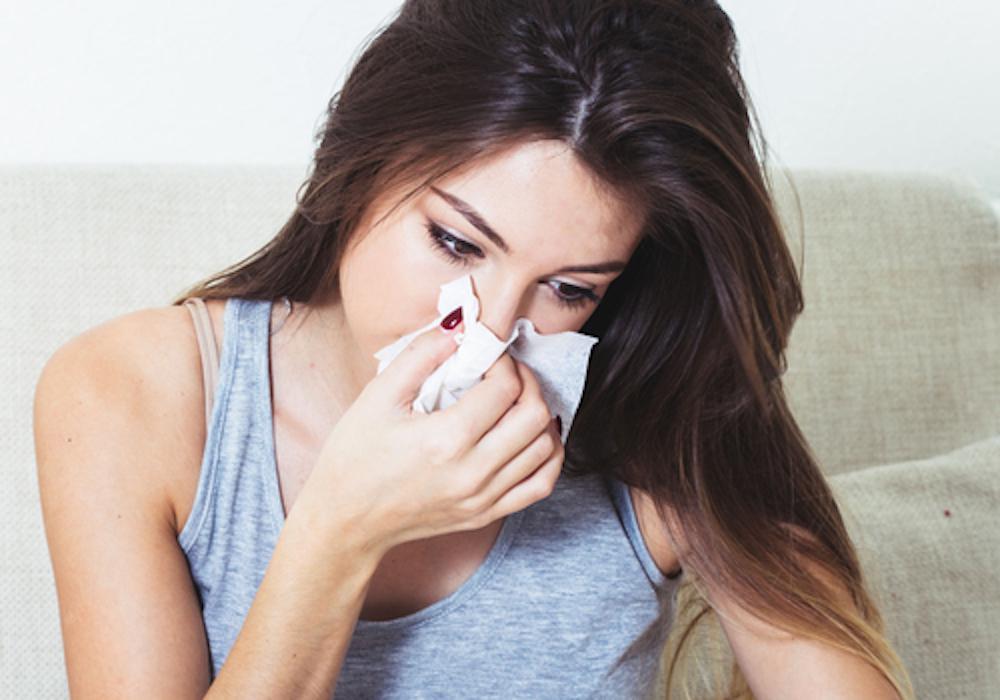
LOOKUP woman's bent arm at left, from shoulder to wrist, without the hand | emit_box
[34,318,379,700]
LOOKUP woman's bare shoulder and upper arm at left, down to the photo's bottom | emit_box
[33,306,225,698]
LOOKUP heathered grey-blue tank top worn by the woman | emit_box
[177,298,679,700]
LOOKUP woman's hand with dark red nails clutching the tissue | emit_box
[289,318,564,553]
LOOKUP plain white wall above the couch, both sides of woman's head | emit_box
[0,0,1000,206]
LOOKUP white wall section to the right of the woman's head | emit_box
[720,0,1000,206]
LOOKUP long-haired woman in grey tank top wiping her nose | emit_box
[36,0,912,698]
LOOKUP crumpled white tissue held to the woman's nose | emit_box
[375,274,599,441]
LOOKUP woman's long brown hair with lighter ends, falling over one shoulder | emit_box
[173,0,912,698]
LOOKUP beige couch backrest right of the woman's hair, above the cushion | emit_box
[773,170,1000,474]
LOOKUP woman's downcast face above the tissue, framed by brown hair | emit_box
[339,141,640,382]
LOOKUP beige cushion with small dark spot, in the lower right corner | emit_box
[830,435,1000,698]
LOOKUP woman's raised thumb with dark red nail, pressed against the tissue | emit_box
[373,316,465,412]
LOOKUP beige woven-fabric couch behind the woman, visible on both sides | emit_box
[0,166,1000,700]
